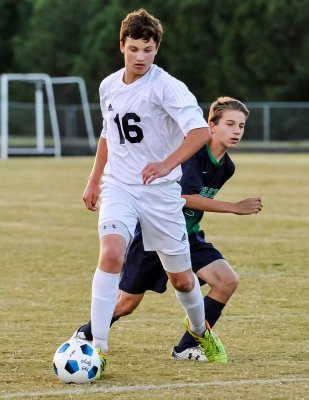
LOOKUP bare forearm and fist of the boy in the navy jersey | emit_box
[182,194,263,215]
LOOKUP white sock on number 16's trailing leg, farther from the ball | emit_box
[175,274,205,336]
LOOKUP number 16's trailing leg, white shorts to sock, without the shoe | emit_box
[140,183,205,335]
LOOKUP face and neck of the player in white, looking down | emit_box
[120,37,158,83]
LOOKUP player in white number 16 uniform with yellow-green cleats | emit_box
[83,9,225,378]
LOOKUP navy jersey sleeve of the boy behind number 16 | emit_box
[179,149,203,195]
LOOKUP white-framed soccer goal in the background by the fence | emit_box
[0,73,96,159]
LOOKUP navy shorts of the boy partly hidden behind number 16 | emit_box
[119,230,224,294]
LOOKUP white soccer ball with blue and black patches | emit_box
[53,338,100,383]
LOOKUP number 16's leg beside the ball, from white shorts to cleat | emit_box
[91,184,138,378]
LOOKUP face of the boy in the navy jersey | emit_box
[210,110,246,149]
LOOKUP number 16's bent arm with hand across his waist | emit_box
[142,128,211,184]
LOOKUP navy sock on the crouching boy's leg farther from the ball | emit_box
[175,296,225,353]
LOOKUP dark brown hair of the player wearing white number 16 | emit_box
[120,8,163,48]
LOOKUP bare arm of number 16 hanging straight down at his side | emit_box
[83,137,107,211]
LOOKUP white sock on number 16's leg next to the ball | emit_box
[91,268,120,353]
